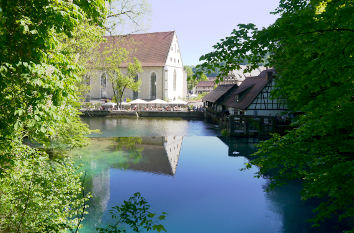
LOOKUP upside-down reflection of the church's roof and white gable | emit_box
[116,136,183,176]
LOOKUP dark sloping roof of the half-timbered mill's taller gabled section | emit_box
[222,70,274,110]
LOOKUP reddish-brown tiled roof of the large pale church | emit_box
[100,31,175,67]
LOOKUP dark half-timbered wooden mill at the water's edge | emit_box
[203,70,288,137]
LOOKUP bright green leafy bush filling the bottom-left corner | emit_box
[0,146,88,232]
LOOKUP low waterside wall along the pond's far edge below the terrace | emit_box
[81,110,204,120]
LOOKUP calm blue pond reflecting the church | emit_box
[73,118,330,233]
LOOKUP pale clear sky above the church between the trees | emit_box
[146,0,279,65]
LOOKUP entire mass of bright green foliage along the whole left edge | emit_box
[0,0,106,232]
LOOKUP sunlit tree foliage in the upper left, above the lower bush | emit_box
[0,0,105,154]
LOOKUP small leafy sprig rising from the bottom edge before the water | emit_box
[97,192,167,233]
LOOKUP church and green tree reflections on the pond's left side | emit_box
[72,136,183,232]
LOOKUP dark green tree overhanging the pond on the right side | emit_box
[199,0,354,229]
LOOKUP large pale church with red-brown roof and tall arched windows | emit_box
[88,31,187,100]
